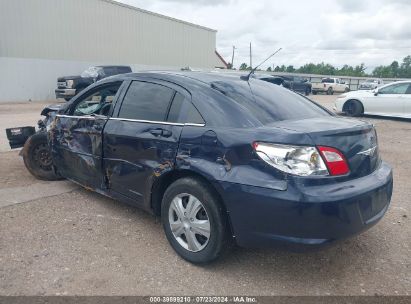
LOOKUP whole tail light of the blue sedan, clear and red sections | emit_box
[253,142,350,176]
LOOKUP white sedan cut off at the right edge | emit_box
[334,80,411,118]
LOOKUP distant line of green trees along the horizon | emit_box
[240,55,411,78]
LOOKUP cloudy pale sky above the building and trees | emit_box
[117,0,411,71]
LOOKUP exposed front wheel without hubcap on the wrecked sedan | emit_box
[23,132,61,181]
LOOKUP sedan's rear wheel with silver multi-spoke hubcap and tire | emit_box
[161,177,230,264]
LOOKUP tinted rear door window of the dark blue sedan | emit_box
[118,81,175,121]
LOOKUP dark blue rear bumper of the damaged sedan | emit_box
[219,163,393,248]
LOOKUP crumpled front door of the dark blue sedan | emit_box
[50,82,122,189]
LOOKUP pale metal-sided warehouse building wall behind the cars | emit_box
[0,0,216,101]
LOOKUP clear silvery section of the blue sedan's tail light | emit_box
[253,142,328,176]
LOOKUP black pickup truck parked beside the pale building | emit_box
[55,66,132,101]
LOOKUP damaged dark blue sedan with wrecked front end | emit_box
[6,72,393,263]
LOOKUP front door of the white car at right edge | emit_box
[364,83,409,116]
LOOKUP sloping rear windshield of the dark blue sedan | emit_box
[212,80,330,125]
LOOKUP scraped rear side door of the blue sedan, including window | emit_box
[103,80,188,205]
